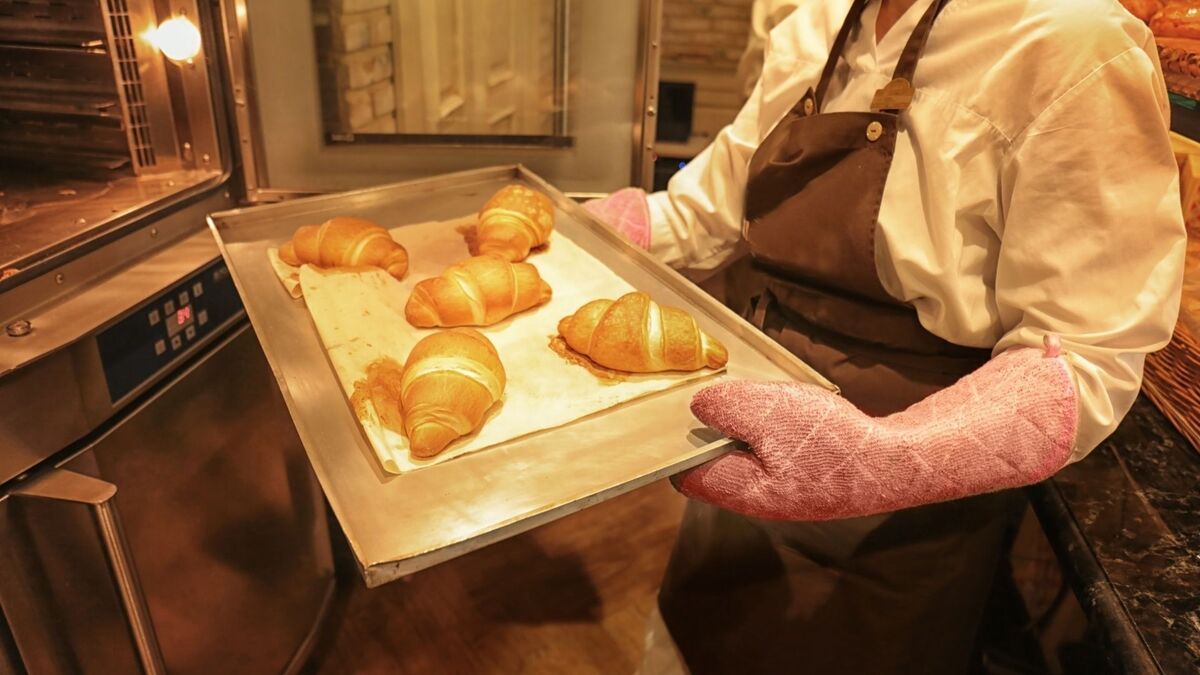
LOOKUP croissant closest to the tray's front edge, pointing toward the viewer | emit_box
[400,328,505,458]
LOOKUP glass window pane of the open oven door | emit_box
[312,0,578,147]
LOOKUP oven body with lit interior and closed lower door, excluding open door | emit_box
[0,0,334,674]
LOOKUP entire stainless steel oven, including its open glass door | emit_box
[0,0,660,674]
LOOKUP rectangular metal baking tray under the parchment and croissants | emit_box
[209,166,833,587]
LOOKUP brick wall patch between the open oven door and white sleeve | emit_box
[662,0,751,70]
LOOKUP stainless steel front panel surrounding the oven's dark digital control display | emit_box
[0,186,232,483]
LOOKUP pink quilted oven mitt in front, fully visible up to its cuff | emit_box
[672,338,1078,520]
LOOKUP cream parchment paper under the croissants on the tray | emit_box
[269,215,714,473]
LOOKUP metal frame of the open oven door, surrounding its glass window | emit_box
[222,0,661,202]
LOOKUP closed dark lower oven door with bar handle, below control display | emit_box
[0,323,334,675]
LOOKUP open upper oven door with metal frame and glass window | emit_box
[222,0,661,202]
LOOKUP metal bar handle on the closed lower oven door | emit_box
[12,468,166,675]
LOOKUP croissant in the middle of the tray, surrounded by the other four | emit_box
[404,256,551,328]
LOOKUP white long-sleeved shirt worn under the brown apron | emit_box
[650,0,1186,460]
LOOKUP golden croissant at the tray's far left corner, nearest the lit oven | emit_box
[280,216,408,279]
